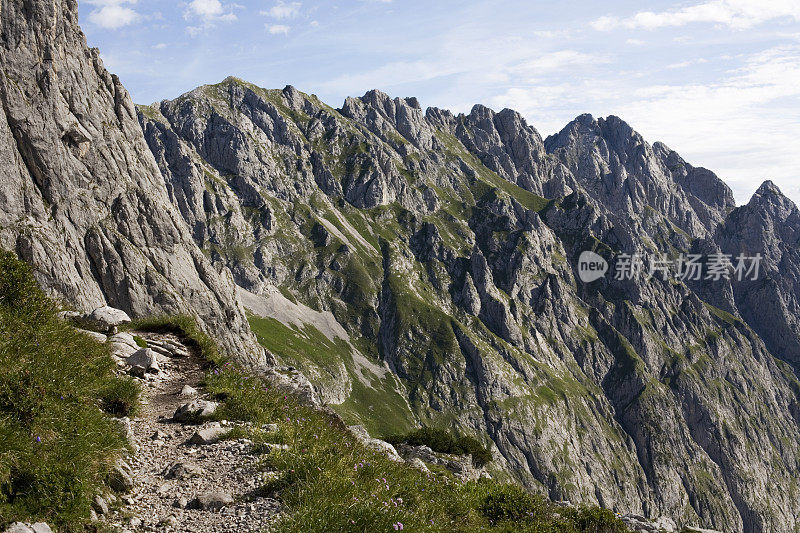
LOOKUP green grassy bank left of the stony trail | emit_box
[0,252,139,531]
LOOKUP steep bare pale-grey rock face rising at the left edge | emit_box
[0,0,263,361]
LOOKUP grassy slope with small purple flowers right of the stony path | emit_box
[134,317,625,533]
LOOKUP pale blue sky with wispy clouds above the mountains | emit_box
[79,0,800,203]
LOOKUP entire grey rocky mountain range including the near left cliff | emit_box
[0,0,800,532]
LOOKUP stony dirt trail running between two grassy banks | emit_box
[104,333,281,533]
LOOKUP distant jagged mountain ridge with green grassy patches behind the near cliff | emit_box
[139,78,800,531]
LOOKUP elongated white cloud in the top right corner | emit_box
[590,0,800,31]
